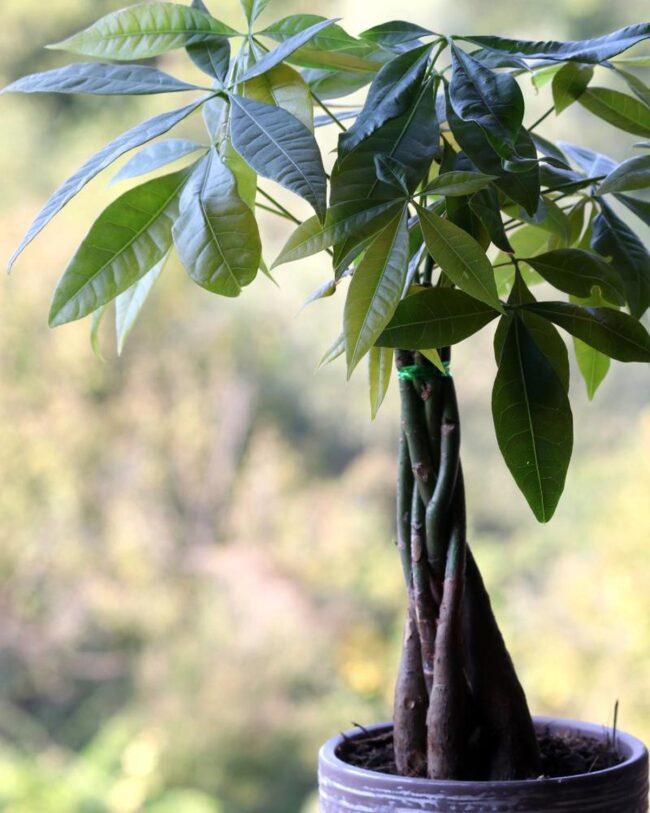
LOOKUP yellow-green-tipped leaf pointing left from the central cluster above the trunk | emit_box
[271,200,403,268]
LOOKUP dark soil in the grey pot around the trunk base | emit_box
[337,729,623,779]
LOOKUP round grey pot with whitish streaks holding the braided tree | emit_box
[319,717,648,813]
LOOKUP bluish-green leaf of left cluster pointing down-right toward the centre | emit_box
[230,94,327,220]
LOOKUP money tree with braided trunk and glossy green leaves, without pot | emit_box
[5,0,650,779]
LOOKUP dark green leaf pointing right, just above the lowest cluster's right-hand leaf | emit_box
[522,248,625,305]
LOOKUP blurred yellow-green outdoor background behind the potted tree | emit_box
[0,0,650,813]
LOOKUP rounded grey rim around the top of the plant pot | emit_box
[319,715,648,790]
